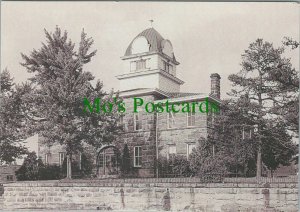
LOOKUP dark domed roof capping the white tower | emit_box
[124,28,177,62]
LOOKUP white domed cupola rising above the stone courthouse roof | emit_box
[117,28,184,92]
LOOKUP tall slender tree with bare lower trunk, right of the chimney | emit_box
[229,39,292,177]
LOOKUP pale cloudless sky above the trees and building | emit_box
[1,2,299,161]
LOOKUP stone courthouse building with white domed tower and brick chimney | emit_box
[39,28,220,177]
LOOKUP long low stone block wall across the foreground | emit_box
[3,181,298,212]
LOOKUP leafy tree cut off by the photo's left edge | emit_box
[0,69,29,164]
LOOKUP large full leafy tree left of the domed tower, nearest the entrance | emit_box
[22,27,120,178]
